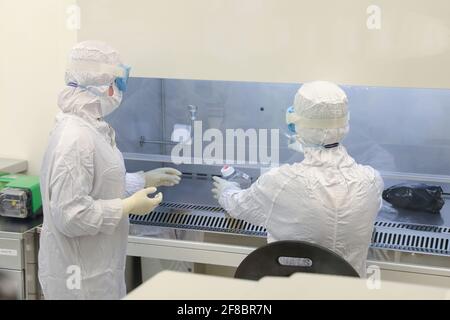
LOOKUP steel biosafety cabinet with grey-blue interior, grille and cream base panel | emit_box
[103,78,450,286]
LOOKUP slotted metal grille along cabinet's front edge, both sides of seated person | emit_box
[130,202,450,255]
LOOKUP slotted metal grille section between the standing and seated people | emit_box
[130,202,267,237]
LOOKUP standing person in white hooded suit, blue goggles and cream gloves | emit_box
[39,41,181,299]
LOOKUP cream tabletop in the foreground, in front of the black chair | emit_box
[125,271,450,300]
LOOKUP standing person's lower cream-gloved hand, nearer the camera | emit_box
[122,187,162,215]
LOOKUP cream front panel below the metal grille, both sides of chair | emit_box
[128,222,450,288]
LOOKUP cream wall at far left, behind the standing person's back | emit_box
[0,0,76,174]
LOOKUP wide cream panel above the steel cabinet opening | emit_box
[78,0,450,88]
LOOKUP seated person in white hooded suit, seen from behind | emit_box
[212,81,383,277]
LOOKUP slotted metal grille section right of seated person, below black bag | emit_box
[372,221,450,255]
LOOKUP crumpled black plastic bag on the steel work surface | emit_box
[383,183,445,213]
